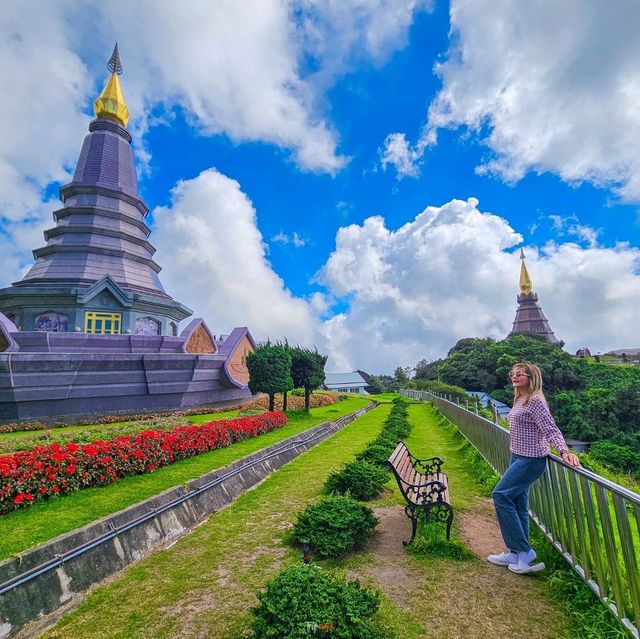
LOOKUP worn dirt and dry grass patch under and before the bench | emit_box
[350,506,567,639]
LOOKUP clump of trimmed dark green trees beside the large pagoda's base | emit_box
[246,342,327,411]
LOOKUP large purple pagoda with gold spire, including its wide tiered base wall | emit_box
[0,45,255,421]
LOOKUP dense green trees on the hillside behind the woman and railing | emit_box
[361,335,640,477]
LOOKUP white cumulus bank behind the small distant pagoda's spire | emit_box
[320,198,640,372]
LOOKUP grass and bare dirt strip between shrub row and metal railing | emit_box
[344,406,568,639]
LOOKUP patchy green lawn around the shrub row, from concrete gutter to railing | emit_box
[45,404,567,639]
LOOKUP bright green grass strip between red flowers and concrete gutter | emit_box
[0,397,371,560]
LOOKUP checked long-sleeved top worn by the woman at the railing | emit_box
[508,395,569,457]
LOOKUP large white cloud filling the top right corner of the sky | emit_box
[382,0,640,201]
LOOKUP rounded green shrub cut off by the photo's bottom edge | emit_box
[252,564,386,639]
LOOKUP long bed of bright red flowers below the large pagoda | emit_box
[0,411,287,514]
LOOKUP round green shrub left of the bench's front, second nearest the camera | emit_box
[288,495,378,557]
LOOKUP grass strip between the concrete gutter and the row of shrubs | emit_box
[45,405,391,639]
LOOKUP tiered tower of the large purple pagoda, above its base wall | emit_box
[0,45,191,335]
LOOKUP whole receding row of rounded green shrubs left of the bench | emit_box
[253,397,411,639]
